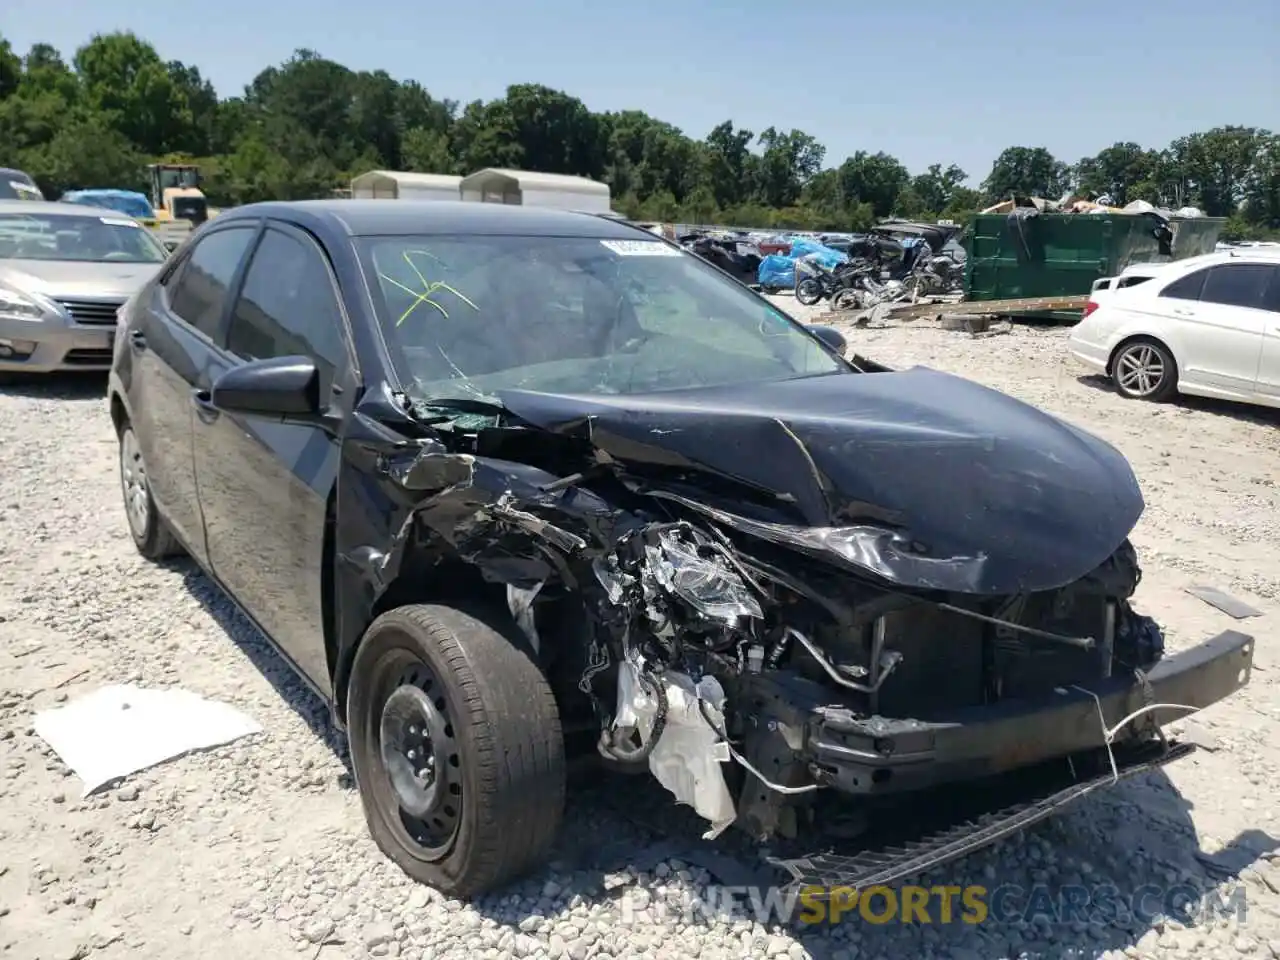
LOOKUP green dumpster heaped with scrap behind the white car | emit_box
[963,214,1226,320]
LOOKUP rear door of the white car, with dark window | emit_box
[1158,262,1272,394]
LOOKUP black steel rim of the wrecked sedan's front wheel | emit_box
[378,655,463,860]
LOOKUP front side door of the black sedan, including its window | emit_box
[186,223,355,694]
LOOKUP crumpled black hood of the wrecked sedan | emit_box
[500,367,1144,595]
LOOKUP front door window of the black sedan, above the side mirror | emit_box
[227,229,346,389]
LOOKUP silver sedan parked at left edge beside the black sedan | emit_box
[0,200,168,374]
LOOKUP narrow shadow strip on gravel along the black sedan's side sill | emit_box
[166,559,356,790]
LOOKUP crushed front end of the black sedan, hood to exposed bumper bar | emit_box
[366,369,1253,901]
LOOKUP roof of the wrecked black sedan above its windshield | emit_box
[218,198,653,239]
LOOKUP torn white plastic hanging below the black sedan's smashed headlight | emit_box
[613,660,737,840]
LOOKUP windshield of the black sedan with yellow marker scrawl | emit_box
[364,237,845,402]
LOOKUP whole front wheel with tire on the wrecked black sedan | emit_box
[347,604,566,897]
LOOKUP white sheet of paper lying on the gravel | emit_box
[35,686,262,796]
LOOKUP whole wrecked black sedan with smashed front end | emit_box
[109,201,1253,896]
